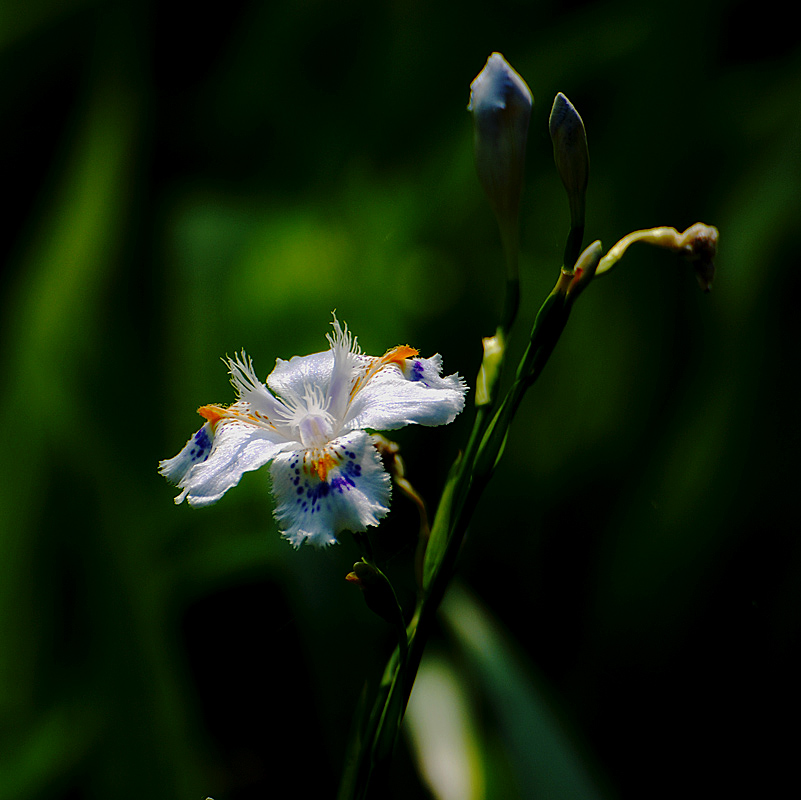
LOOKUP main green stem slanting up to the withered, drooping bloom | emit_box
[339,216,717,800]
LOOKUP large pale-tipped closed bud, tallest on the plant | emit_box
[467,53,533,229]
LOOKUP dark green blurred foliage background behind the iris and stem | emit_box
[0,0,801,800]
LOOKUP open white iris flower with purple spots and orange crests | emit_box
[159,317,467,547]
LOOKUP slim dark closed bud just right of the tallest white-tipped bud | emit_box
[548,92,590,269]
